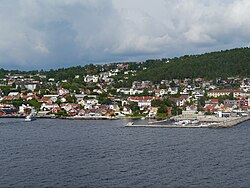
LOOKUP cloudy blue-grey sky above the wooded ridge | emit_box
[0,0,250,70]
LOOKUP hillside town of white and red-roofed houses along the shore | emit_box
[0,63,250,119]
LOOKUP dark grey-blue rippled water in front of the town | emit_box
[0,119,250,187]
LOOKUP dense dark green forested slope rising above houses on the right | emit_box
[136,48,250,81]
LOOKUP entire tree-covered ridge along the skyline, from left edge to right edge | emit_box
[0,48,250,84]
